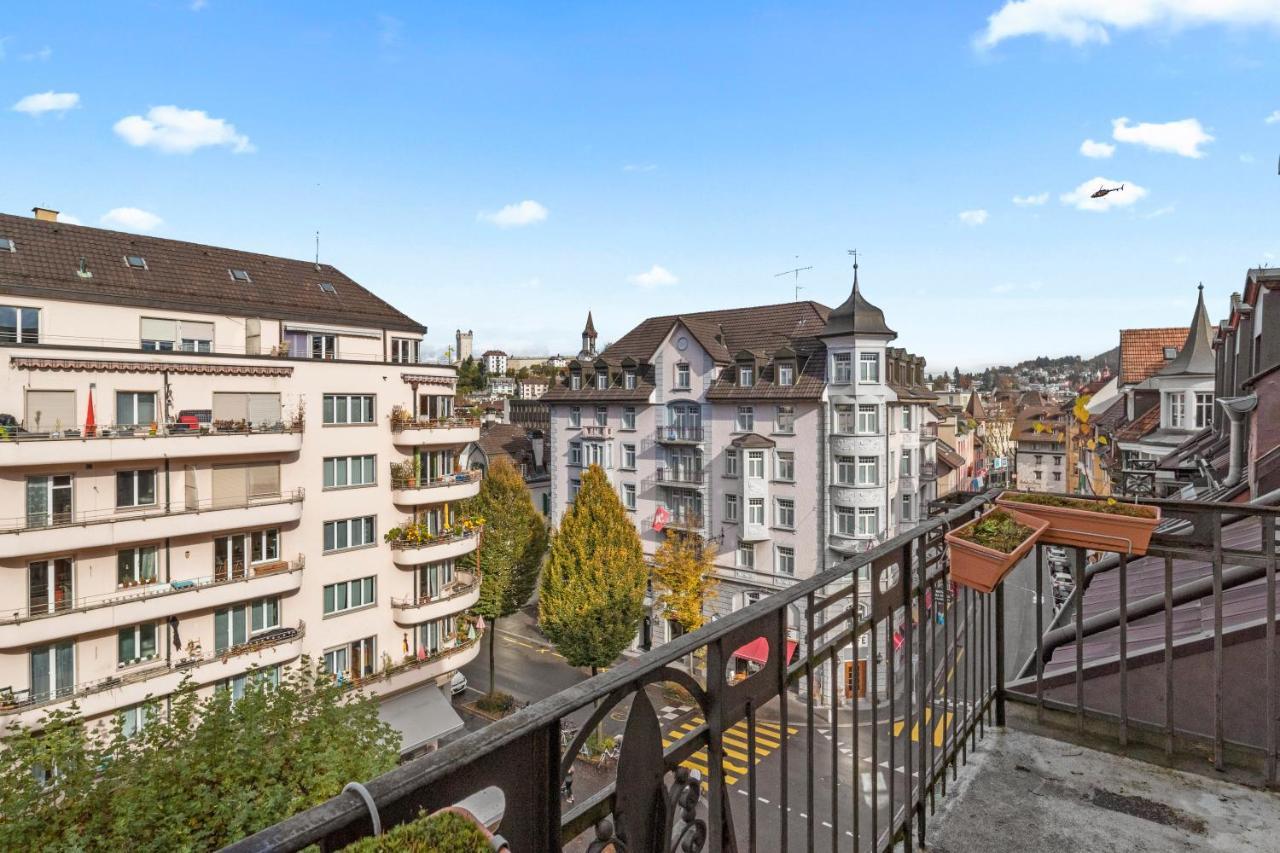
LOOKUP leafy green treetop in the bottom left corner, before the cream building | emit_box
[0,658,399,852]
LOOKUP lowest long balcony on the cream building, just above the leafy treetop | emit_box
[0,621,306,727]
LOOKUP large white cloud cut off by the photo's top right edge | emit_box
[977,0,1280,47]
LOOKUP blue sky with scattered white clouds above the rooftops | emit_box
[0,0,1280,370]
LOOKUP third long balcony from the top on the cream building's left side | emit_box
[0,555,305,649]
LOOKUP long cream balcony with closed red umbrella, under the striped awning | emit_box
[0,423,302,467]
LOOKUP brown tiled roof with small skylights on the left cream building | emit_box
[0,214,425,333]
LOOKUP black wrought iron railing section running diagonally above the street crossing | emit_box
[232,493,1004,852]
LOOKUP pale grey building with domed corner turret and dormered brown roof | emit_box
[541,274,936,696]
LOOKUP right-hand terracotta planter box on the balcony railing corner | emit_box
[996,492,1160,557]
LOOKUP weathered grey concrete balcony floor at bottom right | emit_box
[928,729,1280,853]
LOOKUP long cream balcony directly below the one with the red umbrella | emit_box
[0,488,305,560]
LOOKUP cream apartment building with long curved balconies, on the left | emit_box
[0,215,479,749]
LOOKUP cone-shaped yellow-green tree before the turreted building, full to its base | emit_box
[538,465,649,675]
